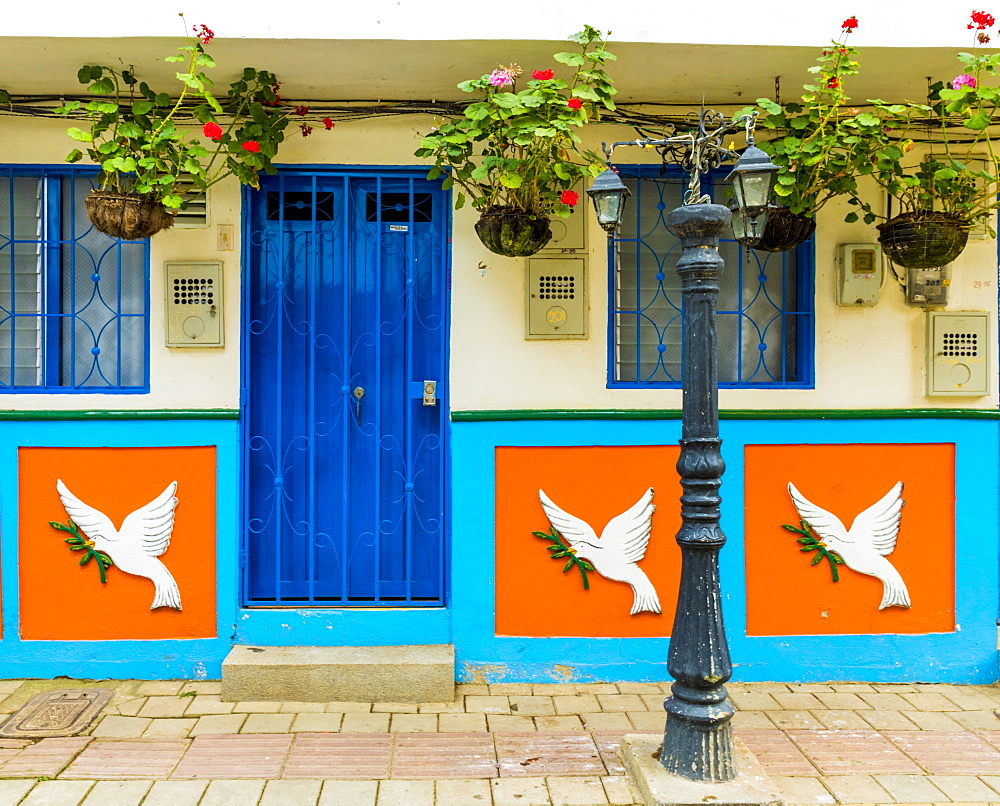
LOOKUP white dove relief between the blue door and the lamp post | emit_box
[538,487,663,616]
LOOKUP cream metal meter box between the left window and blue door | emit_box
[164,261,225,347]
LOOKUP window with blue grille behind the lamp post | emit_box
[608,165,813,388]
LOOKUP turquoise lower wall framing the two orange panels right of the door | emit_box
[452,419,1000,683]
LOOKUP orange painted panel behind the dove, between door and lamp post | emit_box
[496,446,681,637]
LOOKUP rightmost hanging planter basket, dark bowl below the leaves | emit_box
[878,210,969,269]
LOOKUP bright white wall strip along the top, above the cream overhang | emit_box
[3,0,971,46]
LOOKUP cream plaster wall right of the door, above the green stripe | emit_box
[451,127,998,410]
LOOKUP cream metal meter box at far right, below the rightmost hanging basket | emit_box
[927,311,991,397]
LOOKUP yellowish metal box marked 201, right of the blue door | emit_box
[524,257,587,339]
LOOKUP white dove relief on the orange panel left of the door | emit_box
[56,479,181,610]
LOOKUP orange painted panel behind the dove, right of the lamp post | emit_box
[745,444,955,635]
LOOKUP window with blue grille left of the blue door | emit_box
[0,166,149,393]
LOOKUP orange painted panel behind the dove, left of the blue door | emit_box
[18,447,216,641]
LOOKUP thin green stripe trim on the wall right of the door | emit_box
[451,409,1000,423]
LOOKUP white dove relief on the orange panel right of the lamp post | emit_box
[788,481,910,610]
